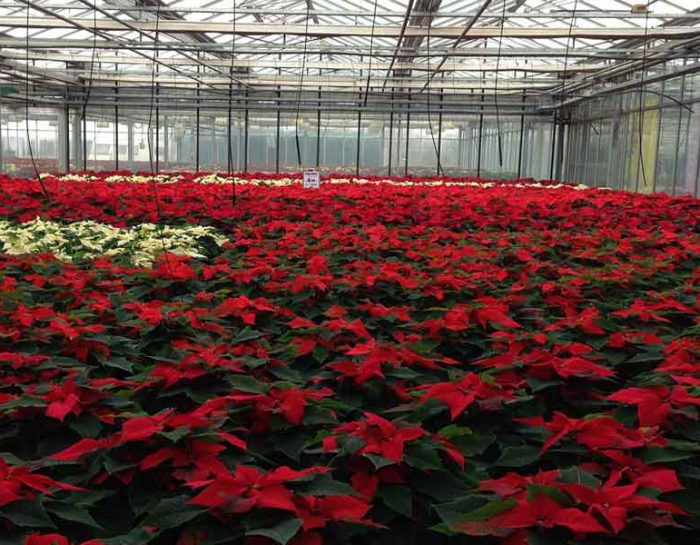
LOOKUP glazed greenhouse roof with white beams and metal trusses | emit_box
[0,0,700,110]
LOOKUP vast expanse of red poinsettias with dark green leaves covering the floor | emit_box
[0,173,700,545]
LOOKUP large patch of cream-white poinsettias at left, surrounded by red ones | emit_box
[0,218,228,266]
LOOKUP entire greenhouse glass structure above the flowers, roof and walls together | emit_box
[0,0,700,191]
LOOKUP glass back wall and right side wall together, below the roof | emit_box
[0,81,700,196]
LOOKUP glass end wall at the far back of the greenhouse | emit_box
[0,105,553,183]
